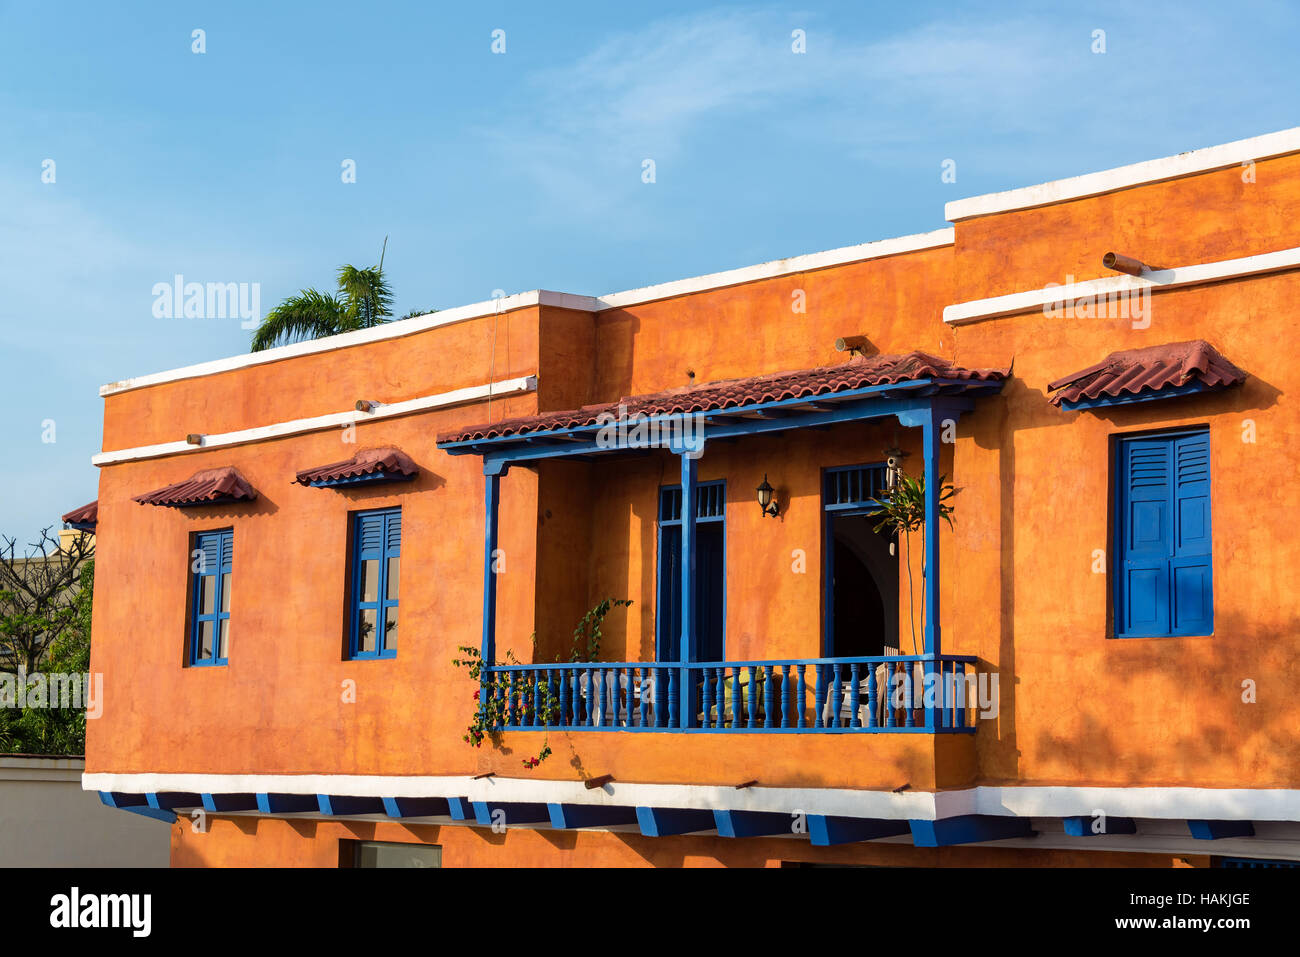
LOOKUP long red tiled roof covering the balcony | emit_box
[438,351,1009,446]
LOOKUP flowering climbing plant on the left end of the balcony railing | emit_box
[451,598,632,768]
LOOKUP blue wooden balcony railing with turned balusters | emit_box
[485,654,979,733]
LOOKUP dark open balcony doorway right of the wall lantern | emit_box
[823,465,894,658]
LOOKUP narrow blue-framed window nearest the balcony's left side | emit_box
[348,508,402,659]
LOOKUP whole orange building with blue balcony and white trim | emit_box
[85,129,1300,866]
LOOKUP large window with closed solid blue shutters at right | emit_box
[1113,428,1214,638]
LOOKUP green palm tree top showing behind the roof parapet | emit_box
[251,239,393,352]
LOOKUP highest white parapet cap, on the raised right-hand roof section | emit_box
[944,126,1300,222]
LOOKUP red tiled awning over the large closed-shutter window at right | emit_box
[1048,339,1245,408]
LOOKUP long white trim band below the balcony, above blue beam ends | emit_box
[82,772,1300,820]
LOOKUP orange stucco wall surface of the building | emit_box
[87,149,1300,863]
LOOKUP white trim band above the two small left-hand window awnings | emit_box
[91,376,537,465]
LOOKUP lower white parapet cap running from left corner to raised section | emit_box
[99,226,953,397]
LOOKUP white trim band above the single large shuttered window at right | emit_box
[944,246,1300,325]
